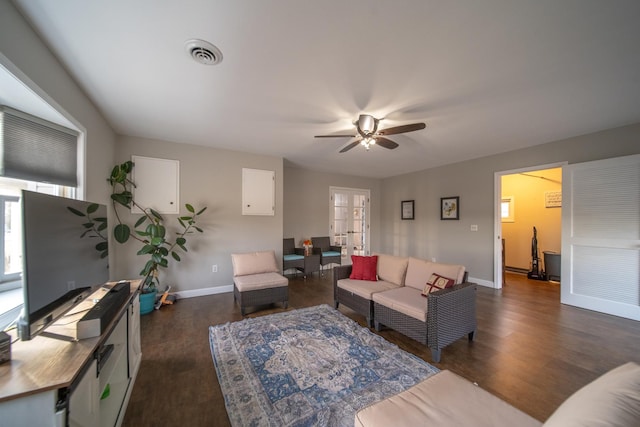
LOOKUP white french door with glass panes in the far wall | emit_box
[330,187,370,264]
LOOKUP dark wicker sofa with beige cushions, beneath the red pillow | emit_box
[333,254,477,362]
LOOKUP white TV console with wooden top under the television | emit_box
[0,280,142,427]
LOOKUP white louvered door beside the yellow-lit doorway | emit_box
[561,155,640,320]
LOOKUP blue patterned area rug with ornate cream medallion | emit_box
[209,305,438,427]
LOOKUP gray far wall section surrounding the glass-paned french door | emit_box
[280,167,382,251]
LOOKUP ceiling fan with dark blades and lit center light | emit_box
[315,114,427,153]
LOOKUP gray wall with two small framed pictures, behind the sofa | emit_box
[380,124,640,282]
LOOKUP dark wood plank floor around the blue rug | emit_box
[124,273,640,427]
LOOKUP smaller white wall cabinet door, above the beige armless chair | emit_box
[242,168,276,215]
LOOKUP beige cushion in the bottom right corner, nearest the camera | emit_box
[544,362,640,427]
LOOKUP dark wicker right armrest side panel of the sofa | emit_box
[427,282,477,350]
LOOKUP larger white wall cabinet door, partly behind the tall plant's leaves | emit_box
[131,156,180,214]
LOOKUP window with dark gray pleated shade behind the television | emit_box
[0,105,79,330]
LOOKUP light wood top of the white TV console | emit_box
[0,280,140,402]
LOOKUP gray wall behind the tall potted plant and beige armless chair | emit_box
[115,136,283,295]
